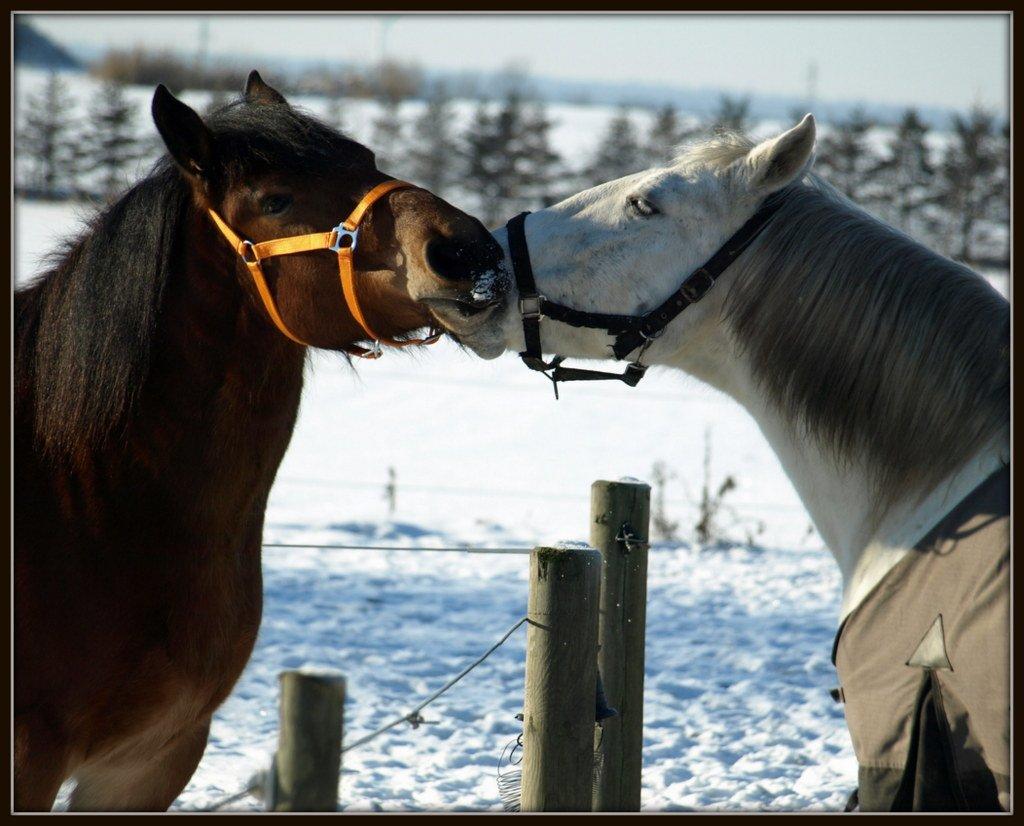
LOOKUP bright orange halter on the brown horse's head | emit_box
[209,180,441,358]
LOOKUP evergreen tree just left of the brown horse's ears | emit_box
[79,81,143,198]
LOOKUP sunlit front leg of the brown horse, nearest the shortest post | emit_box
[68,718,210,812]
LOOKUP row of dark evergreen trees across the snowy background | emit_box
[16,75,1010,266]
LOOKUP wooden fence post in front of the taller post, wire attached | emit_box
[520,548,601,812]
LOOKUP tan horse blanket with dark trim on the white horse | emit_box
[833,468,1010,812]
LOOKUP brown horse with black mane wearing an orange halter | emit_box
[14,73,502,811]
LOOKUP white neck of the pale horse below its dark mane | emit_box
[660,307,1009,619]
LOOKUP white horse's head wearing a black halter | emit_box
[463,115,815,361]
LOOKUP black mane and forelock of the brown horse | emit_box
[14,101,374,454]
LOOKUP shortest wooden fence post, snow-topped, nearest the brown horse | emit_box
[267,671,345,812]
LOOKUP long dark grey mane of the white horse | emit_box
[725,175,1010,520]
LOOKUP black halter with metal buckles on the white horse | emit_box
[506,193,782,398]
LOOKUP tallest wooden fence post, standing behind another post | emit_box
[590,481,650,812]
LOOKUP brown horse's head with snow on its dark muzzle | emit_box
[153,72,507,349]
